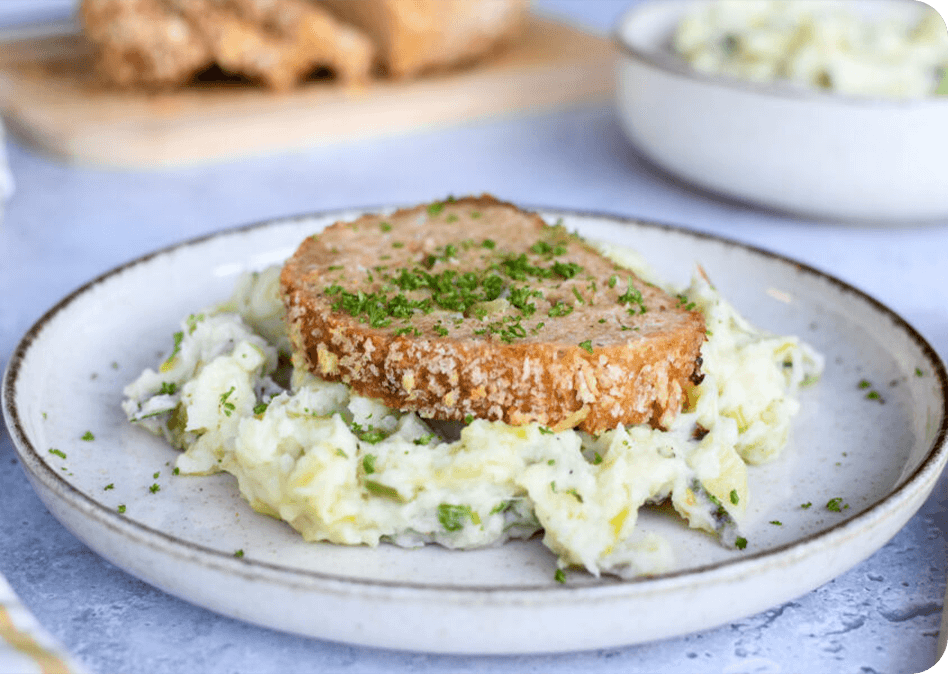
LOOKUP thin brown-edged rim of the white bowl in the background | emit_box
[612,0,948,112]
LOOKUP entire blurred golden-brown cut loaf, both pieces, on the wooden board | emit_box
[80,0,529,90]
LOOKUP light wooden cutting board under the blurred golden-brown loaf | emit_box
[0,17,615,169]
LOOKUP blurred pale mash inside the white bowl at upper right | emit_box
[672,0,948,98]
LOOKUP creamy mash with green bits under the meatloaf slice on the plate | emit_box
[123,247,822,577]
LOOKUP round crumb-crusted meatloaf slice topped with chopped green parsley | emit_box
[281,195,705,433]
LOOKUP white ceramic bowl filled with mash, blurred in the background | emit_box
[616,0,948,223]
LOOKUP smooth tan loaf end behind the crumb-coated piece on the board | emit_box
[320,0,529,78]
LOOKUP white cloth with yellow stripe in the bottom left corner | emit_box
[0,576,88,674]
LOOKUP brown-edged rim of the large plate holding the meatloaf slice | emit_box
[0,206,948,640]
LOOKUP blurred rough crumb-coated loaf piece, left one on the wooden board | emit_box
[82,0,375,90]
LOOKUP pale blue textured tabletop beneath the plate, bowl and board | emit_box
[0,0,948,674]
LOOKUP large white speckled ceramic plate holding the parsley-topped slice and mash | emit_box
[3,211,948,653]
